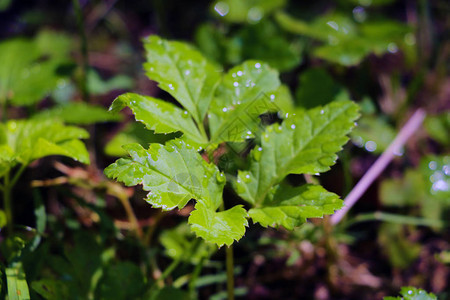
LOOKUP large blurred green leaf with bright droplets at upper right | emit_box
[276,12,410,66]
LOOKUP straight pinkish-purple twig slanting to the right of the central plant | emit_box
[331,109,426,225]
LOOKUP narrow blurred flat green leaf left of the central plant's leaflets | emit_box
[33,102,122,125]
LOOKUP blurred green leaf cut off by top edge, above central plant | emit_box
[212,0,286,23]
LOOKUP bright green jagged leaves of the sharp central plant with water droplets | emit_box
[105,36,358,247]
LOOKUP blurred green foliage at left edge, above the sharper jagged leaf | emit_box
[0,31,71,105]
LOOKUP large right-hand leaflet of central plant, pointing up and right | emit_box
[236,101,358,206]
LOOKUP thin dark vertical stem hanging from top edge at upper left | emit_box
[72,0,90,102]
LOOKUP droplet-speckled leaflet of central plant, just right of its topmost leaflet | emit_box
[208,61,280,143]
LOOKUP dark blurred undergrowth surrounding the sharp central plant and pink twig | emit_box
[0,0,450,299]
